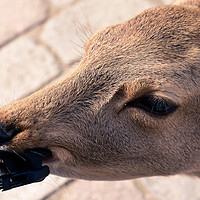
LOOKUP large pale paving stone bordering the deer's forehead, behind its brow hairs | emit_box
[41,0,158,64]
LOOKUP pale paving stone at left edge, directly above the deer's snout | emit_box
[0,38,60,107]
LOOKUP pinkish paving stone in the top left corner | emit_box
[0,0,47,47]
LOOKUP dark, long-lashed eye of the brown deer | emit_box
[126,96,177,115]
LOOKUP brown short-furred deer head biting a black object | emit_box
[0,0,200,189]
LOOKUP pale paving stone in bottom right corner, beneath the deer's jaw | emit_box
[137,175,200,200]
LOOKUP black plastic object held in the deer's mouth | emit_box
[0,148,51,191]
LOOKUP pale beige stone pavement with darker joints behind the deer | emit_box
[0,0,200,200]
